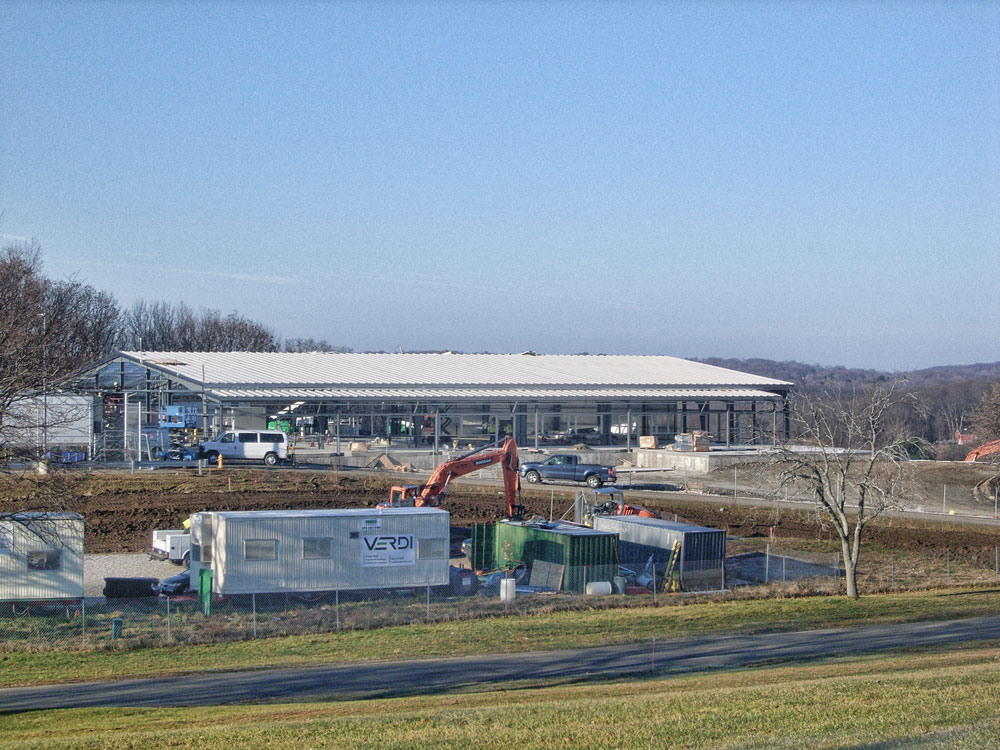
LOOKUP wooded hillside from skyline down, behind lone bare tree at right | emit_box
[698,357,1000,450]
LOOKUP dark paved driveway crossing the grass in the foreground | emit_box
[0,617,1000,711]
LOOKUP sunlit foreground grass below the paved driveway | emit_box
[0,648,1000,750]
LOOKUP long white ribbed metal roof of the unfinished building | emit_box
[120,352,792,397]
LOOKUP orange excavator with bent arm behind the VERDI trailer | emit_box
[377,437,524,518]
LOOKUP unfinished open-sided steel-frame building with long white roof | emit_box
[75,352,792,460]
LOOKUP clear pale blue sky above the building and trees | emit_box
[0,0,1000,369]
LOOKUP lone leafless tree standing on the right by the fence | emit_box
[767,383,914,598]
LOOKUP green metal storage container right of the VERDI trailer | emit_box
[472,521,618,594]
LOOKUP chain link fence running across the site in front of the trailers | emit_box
[0,537,1000,651]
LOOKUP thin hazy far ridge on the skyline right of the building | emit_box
[695,357,1000,388]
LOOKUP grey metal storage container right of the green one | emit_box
[594,516,726,591]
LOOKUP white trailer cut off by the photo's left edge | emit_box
[0,512,83,602]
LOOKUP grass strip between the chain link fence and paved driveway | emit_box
[0,588,1000,687]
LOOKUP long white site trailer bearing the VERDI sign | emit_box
[191,508,451,594]
